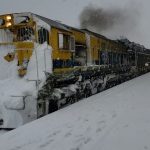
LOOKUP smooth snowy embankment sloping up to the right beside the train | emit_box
[0,73,150,150]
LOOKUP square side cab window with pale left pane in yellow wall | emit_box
[58,33,75,50]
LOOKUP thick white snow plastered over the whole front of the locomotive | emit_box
[0,40,52,128]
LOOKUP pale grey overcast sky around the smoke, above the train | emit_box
[0,0,150,48]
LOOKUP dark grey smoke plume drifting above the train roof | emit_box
[80,3,140,38]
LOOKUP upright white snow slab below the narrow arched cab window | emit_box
[27,43,52,80]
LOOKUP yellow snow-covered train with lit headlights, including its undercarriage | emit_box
[0,12,150,129]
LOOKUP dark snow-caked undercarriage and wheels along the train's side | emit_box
[37,65,148,118]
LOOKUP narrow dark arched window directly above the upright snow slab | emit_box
[38,27,49,44]
